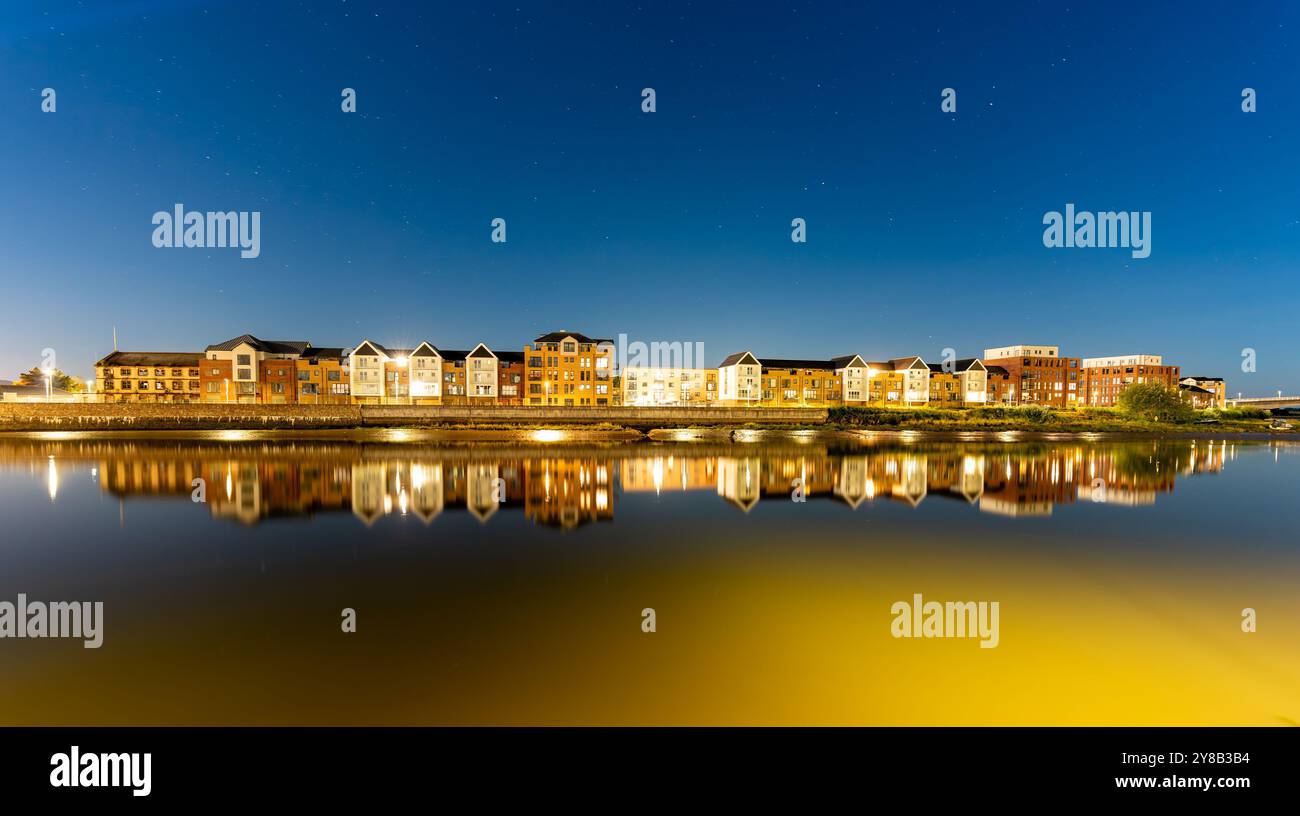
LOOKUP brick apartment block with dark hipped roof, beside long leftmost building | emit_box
[199,334,311,404]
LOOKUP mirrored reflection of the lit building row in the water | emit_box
[42,440,1235,529]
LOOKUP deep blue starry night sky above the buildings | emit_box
[0,0,1300,394]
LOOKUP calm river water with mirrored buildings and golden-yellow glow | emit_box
[0,437,1300,725]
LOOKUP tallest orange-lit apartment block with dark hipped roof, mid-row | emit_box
[524,331,614,407]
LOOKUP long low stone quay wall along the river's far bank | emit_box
[0,403,827,431]
